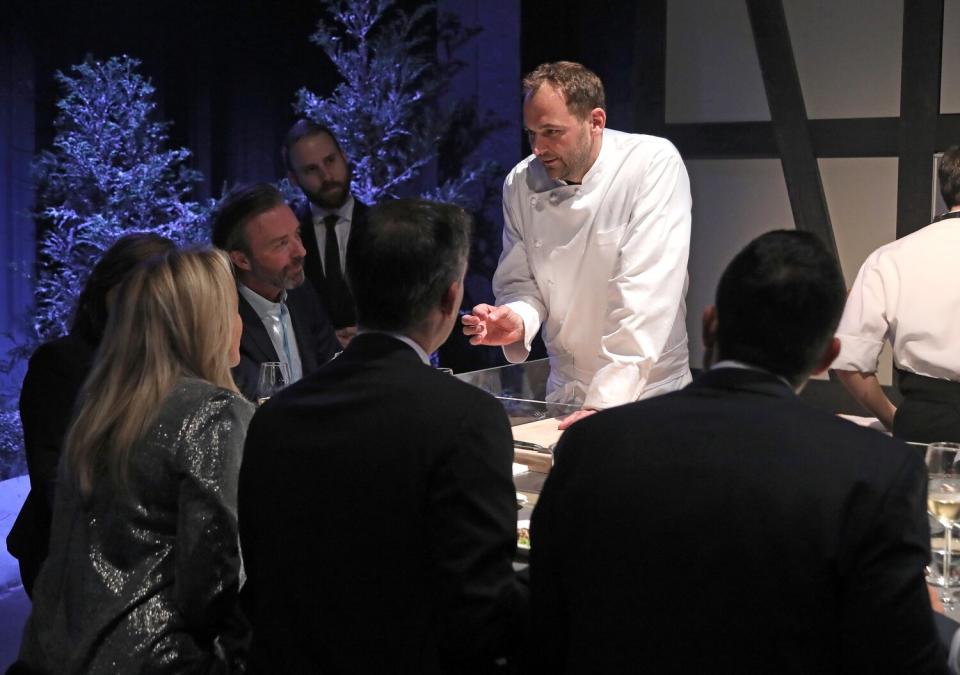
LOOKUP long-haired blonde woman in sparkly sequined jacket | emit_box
[11,251,253,673]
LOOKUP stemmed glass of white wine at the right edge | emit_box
[926,443,960,604]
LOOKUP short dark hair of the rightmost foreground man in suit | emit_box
[717,230,846,386]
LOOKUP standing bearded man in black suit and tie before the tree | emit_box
[282,119,367,346]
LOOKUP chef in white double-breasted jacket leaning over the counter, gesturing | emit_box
[463,61,691,428]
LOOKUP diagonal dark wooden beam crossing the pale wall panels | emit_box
[747,0,837,255]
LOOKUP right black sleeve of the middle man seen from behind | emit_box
[427,392,526,672]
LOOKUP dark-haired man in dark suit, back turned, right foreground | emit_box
[530,231,946,675]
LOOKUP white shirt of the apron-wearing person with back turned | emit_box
[831,218,960,381]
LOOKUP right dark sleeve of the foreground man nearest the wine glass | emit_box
[836,454,947,673]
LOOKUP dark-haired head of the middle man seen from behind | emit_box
[347,199,472,332]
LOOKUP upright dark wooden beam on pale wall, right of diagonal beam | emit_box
[897,0,943,238]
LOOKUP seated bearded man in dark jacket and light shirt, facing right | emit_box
[212,183,340,401]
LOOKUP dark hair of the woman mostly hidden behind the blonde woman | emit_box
[70,232,177,345]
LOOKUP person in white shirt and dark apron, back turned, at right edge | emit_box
[833,146,960,443]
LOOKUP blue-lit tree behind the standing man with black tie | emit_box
[294,0,499,210]
